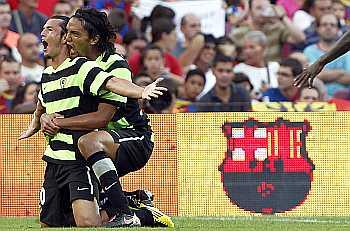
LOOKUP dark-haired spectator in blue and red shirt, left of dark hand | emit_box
[263,58,303,102]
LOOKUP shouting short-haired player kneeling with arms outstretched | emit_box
[20,16,162,227]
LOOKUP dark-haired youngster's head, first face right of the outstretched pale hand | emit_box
[178,69,205,102]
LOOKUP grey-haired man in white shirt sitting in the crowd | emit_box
[234,31,279,96]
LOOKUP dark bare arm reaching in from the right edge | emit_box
[294,31,350,87]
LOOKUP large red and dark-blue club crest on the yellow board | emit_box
[219,118,315,214]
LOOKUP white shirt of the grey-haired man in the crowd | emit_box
[233,62,279,92]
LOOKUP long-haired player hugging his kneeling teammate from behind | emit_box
[39,8,173,226]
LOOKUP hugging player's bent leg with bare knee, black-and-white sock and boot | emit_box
[78,131,139,226]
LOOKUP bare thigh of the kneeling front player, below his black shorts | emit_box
[72,199,101,227]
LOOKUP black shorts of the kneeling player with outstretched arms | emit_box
[40,163,97,227]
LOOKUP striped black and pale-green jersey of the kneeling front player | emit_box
[39,58,126,164]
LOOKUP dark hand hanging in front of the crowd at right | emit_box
[294,62,323,88]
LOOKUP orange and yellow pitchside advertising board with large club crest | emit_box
[0,112,350,216]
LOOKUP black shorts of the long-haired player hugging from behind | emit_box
[107,128,154,177]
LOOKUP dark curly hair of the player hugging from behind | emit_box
[72,7,116,53]
